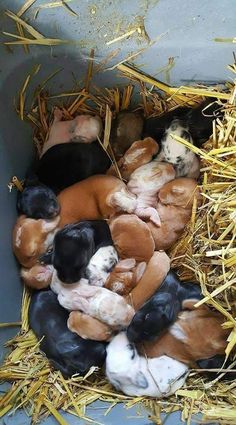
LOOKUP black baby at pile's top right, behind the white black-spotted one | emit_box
[144,98,223,147]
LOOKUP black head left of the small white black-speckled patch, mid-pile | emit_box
[52,222,95,284]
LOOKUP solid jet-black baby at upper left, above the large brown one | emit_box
[35,142,111,194]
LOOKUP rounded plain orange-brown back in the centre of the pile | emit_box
[109,214,155,262]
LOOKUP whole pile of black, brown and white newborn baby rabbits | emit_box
[13,101,229,397]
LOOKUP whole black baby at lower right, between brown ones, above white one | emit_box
[127,270,202,343]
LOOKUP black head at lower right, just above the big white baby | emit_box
[127,292,179,343]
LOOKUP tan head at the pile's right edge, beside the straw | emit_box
[158,177,200,208]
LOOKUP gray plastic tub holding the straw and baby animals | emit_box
[0,0,236,425]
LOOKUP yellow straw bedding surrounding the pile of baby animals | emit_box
[0,1,236,425]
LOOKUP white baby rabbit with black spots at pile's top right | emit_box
[155,119,200,179]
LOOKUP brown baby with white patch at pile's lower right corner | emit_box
[140,300,230,367]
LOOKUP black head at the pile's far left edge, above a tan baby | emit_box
[17,185,60,219]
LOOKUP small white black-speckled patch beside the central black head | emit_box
[86,245,118,286]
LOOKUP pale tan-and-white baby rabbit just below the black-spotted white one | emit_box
[127,161,175,227]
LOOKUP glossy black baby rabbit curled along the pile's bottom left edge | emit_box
[29,291,106,378]
